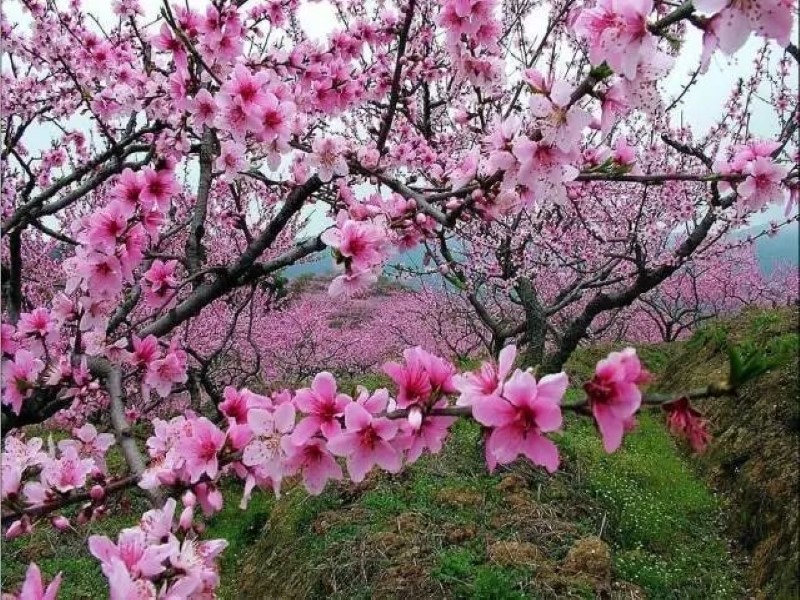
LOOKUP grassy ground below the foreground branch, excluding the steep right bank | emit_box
[3,318,780,599]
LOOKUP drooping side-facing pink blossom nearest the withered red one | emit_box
[583,348,649,453]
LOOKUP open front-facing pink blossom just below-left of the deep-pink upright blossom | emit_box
[328,402,402,482]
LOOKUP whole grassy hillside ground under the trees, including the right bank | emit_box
[4,311,800,600]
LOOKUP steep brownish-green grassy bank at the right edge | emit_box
[661,309,800,600]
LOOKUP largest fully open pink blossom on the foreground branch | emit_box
[472,370,568,473]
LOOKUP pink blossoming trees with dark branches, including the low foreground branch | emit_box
[0,0,798,598]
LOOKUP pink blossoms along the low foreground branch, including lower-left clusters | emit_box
[2,346,736,598]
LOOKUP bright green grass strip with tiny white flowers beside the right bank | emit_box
[559,414,741,599]
